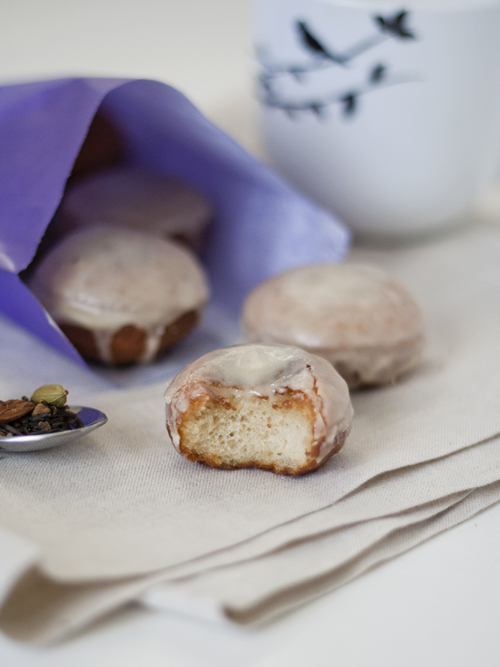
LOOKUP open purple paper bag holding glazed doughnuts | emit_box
[0,78,349,363]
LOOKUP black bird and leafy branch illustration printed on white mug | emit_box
[257,10,421,118]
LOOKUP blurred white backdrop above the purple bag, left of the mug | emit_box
[0,0,264,155]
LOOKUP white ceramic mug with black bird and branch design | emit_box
[255,0,500,237]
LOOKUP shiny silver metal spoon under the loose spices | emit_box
[0,405,108,452]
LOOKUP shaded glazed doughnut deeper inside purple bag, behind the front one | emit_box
[56,167,213,247]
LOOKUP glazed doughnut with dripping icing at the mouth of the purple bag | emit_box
[29,227,208,364]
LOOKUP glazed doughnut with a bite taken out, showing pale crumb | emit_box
[165,344,353,475]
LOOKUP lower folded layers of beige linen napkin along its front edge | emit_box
[0,483,500,642]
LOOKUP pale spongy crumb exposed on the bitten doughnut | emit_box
[179,388,316,475]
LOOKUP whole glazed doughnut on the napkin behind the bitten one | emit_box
[242,264,424,388]
